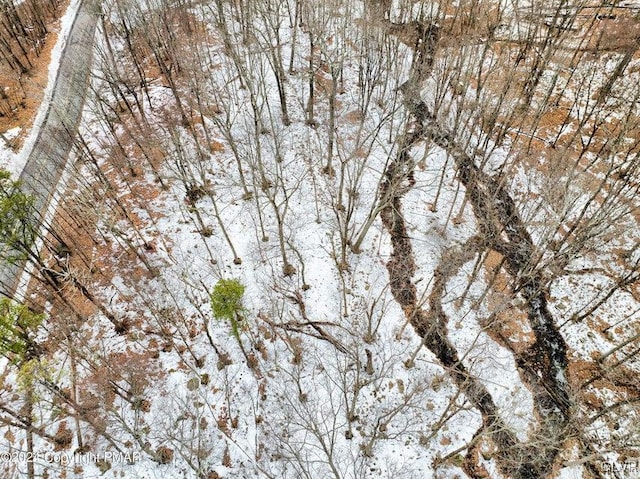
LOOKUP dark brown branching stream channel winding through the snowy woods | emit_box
[379,16,571,479]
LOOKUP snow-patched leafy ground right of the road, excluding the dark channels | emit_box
[0,2,640,479]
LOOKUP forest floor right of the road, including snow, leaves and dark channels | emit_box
[0,0,640,479]
